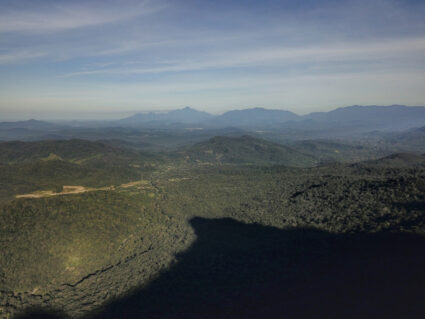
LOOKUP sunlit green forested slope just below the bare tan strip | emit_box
[0,190,164,293]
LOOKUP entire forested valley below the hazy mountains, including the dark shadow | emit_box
[0,110,425,319]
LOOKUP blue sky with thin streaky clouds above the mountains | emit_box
[0,0,425,121]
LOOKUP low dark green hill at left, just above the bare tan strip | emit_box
[0,140,163,202]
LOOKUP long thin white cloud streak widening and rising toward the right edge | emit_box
[62,37,425,77]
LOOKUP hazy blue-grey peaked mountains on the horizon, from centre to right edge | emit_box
[113,105,425,132]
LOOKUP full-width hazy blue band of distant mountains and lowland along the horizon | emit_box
[0,105,425,144]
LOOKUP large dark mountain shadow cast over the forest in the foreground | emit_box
[17,217,425,319]
